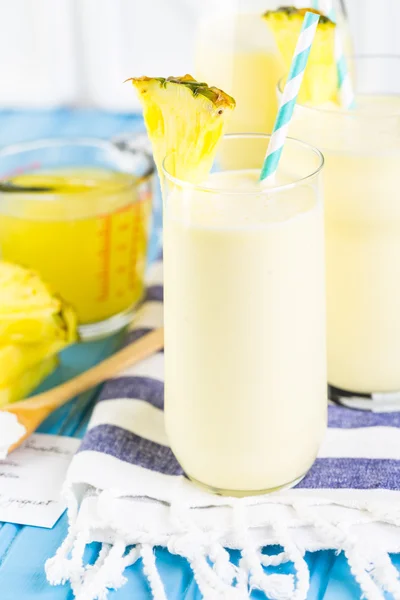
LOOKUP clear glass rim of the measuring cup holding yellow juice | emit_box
[0,134,156,191]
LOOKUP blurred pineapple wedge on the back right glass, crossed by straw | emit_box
[263,6,338,105]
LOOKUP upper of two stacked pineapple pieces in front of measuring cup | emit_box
[0,261,77,345]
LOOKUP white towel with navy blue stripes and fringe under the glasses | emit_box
[46,262,400,600]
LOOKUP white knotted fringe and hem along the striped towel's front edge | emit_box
[46,489,400,600]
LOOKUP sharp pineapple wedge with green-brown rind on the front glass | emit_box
[130,75,235,183]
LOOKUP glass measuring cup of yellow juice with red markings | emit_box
[0,139,154,339]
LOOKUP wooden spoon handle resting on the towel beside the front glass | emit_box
[6,328,164,412]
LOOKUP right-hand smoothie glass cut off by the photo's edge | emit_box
[282,56,400,408]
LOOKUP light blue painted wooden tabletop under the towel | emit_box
[0,110,400,600]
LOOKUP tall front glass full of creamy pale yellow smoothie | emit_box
[163,134,327,496]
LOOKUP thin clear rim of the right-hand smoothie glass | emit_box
[276,54,400,119]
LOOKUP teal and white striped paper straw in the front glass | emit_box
[260,12,319,182]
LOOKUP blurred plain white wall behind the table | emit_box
[0,0,400,111]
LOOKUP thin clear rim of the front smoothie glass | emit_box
[162,133,325,196]
